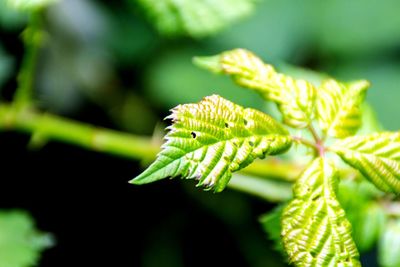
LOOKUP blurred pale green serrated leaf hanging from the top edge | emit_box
[137,0,254,38]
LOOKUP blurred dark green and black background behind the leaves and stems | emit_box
[0,0,400,267]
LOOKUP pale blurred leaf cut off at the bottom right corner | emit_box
[378,218,400,267]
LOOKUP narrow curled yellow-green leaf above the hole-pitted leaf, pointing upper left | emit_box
[195,49,315,128]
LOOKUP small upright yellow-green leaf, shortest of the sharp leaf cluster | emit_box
[316,79,369,138]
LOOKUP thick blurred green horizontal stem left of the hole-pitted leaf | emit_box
[0,104,159,160]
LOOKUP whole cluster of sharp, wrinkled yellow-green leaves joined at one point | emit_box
[132,49,400,267]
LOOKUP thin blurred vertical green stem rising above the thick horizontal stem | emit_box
[13,11,43,107]
